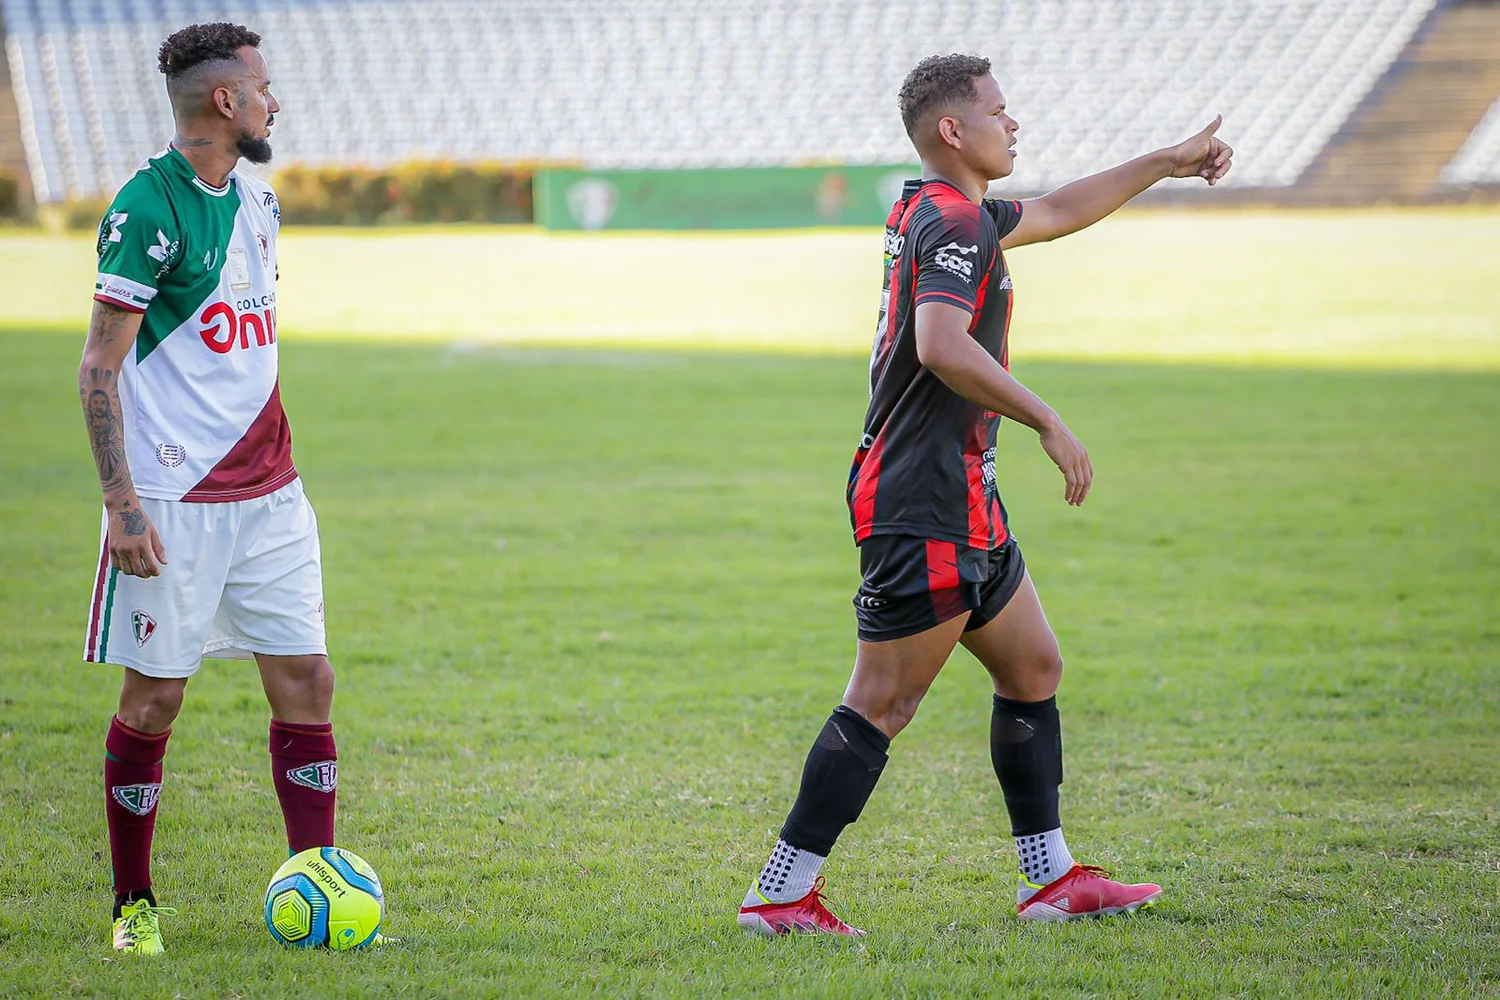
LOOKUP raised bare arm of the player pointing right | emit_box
[1001,115,1235,249]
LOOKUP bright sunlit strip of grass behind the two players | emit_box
[0,208,1500,369]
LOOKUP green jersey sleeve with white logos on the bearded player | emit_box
[95,181,182,312]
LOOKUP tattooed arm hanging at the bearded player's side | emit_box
[78,300,167,577]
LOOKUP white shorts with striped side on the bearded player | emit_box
[84,478,327,678]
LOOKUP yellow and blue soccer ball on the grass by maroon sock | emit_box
[266,847,386,952]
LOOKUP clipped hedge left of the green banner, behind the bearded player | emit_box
[58,162,533,229]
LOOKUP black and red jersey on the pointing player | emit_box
[848,180,1022,549]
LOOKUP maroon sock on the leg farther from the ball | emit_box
[104,717,173,897]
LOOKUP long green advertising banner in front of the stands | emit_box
[533,165,920,229]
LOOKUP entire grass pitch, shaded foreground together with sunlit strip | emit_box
[0,213,1500,999]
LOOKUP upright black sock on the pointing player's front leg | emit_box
[990,694,1062,837]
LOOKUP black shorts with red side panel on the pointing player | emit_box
[854,535,1026,642]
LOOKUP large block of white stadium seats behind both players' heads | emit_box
[0,0,1446,201]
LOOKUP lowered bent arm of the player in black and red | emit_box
[917,301,1094,507]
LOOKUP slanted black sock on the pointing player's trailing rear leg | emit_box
[782,705,891,858]
